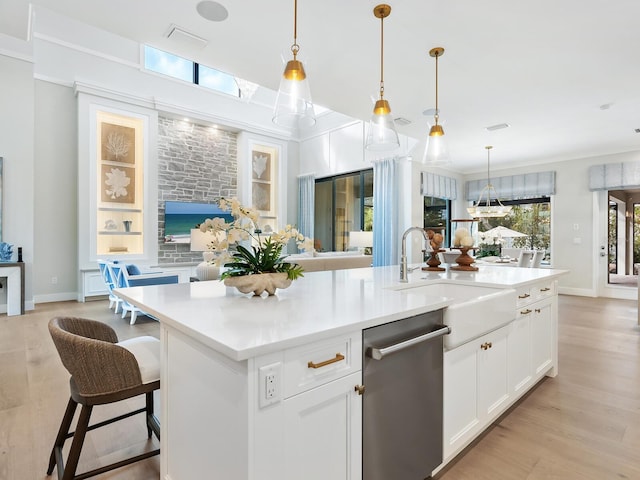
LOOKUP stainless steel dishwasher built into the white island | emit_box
[362,310,450,480]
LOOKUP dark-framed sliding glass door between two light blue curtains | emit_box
[314,169,373,252]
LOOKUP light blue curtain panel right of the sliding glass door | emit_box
[373,158,399,267]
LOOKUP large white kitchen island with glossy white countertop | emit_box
[118,266,565,480]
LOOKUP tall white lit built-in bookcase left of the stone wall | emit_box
[76,85,158,301]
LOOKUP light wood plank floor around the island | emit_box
[0,296,640,480]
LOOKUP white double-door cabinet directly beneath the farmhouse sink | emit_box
[443,325,509,463]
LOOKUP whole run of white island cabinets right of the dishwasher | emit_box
[443,281,558,465]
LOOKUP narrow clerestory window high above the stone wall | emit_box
[144,45,240,97]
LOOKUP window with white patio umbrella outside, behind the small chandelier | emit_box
[478,197,551,263]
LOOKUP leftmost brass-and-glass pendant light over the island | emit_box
[273,0,316,129]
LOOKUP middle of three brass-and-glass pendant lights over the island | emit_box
[365,4,400,152]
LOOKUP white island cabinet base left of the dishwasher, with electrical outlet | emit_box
[160,324,362,480]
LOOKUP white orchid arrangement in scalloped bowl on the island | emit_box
[199,198,313,295]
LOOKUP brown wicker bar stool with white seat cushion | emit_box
[47,317,160,480]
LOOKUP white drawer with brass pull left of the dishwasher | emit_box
[283,332,362,398]
